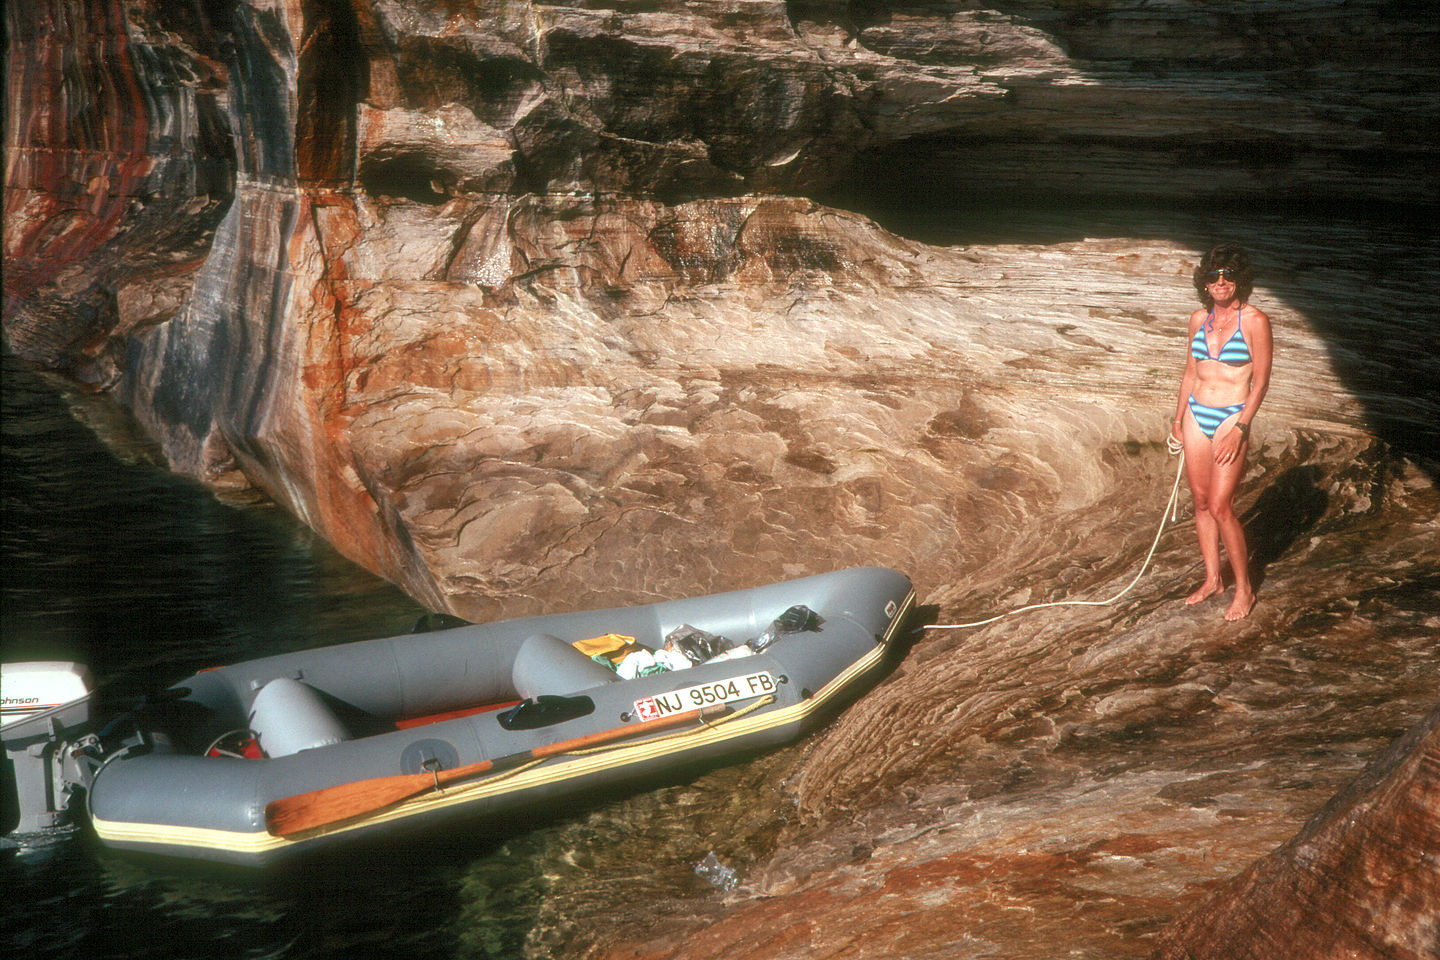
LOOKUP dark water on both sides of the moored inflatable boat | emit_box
[0,356,544,960]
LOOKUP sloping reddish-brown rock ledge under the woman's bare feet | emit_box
[564,432,1440,960]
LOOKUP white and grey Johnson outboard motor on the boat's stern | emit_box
[0,661,99,835]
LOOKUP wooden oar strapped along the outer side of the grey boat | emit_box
[265,704,729,836]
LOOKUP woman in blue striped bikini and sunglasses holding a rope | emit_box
[1171,243,1272,620]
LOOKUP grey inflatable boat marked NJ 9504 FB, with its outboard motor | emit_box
[0,567,914,865]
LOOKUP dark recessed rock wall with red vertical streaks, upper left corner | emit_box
[4,0,235,387]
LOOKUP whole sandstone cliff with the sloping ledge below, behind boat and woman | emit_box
[4,0,1440,957]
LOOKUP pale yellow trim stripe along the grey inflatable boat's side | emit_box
[92,590,914,855]
